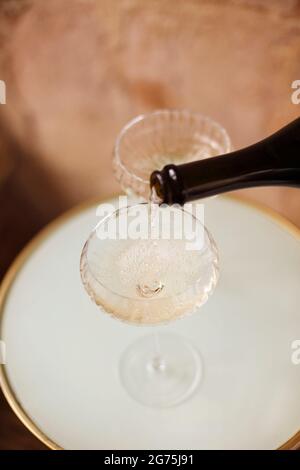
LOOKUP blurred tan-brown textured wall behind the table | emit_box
[0,0,300,225]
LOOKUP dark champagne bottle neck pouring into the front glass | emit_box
[150,118,300,204]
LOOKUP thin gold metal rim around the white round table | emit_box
[0,193,300,450]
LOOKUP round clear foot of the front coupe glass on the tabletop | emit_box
[120,333,202,408]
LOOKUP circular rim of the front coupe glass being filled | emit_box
[80,202,219,302]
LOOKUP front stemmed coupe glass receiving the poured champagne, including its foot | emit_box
[81,203,219,408]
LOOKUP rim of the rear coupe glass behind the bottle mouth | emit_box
[114,108,232,184]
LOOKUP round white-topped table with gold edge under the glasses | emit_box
[0,197,300,450]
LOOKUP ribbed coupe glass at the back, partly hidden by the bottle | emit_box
[113,109,232,200]
